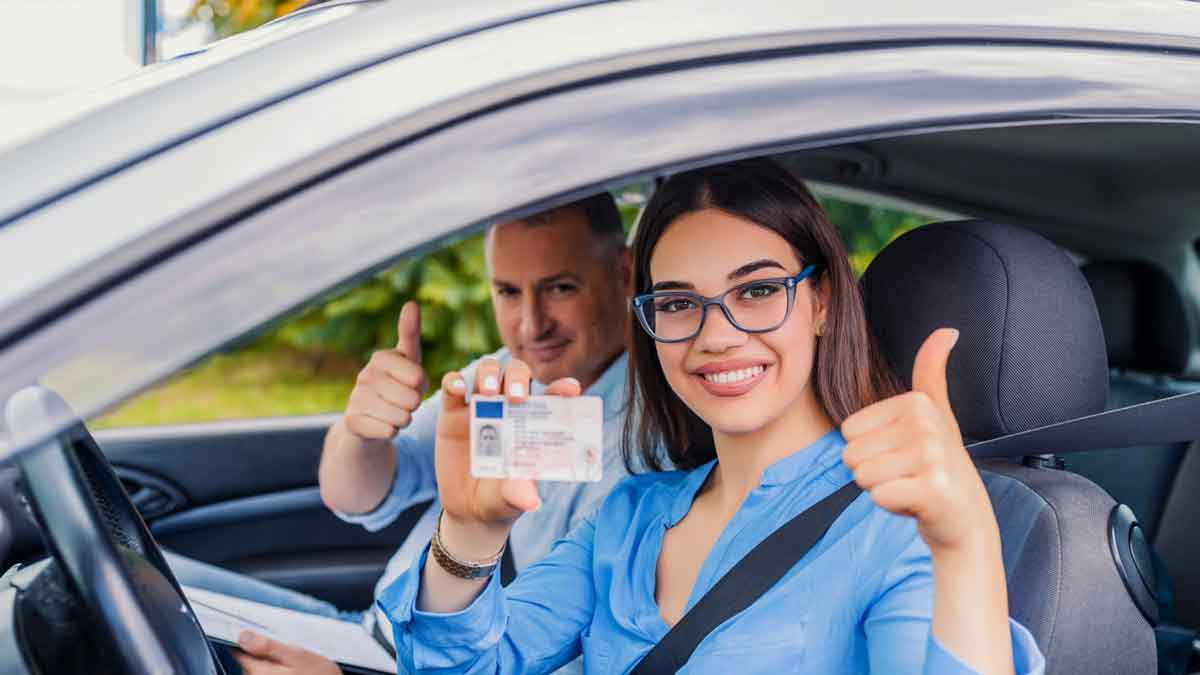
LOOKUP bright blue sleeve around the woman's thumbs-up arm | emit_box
[864,524,1045,675]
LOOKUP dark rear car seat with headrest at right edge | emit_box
[1063,261,1200,662]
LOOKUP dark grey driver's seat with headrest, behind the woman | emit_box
[862,221,1157,675]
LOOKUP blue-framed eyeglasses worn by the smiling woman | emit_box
[634,264,817,342]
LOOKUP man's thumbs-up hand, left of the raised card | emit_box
[343,301,426,441]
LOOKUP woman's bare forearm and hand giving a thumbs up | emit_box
[841,328,1013,675]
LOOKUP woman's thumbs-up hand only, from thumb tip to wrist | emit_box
[841,328,996,554]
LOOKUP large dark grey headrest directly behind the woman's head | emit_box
[862,221,1109,441]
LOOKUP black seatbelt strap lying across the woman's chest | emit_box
[631,483,863,675]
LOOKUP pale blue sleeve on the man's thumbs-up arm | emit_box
[334,352,494,532]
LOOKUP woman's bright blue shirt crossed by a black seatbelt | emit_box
[377,431,1045,675]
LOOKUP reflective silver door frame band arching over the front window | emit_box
[7,39,1200,454]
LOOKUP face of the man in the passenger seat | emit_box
[487,209,631,388]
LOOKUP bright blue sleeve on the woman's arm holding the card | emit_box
[377,509,595,674]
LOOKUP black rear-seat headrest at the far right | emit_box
[1082,261,1192,375]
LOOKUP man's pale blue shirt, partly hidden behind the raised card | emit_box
[334,348,629,638]
